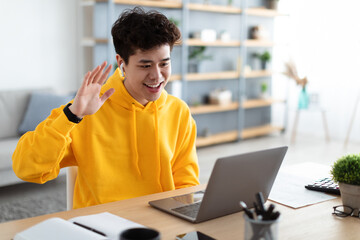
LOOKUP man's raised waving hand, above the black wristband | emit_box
[69,61,115,118]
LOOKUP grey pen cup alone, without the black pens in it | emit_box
[244,214,279,240]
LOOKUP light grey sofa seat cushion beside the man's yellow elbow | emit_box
[0,137,19,171]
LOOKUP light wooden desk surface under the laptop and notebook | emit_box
[0,185,360,240]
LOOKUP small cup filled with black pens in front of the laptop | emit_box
[240,192,280,240]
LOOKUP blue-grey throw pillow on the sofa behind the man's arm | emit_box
[19,92,74,134]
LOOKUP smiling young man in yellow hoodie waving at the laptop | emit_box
[13,8,199,208]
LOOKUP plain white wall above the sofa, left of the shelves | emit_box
[0,0,77,90]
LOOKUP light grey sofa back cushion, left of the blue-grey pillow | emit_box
[0,90,30,139]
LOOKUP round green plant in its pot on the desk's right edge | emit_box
[331,154,360,212]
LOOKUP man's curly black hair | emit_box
[111,7,181,64]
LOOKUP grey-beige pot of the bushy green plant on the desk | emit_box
[339,183,360,212]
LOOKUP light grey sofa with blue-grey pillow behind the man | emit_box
[0,90,74,187]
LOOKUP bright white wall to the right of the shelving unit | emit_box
[273,0,360,141]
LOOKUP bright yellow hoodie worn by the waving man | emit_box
[13,69,199,208]
